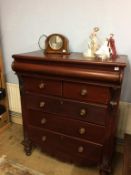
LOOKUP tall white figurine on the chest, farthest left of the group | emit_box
[83,27,99,57]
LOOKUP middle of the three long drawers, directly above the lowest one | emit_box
[28,110,105,144]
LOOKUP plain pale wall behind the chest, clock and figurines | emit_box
[0,0,131,102]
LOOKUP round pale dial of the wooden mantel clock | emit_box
[49,35,63,50]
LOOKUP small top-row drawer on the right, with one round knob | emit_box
[63,82,111,104]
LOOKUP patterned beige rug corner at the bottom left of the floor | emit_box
[0,155,45,175]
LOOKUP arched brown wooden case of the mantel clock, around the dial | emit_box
[44,33,70,54]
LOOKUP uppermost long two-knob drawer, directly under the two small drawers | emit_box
[25,93,108,125]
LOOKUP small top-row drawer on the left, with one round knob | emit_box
[23,77,62,96]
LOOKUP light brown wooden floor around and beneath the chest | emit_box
[0,124,123,175]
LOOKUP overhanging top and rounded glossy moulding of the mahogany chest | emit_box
[12,52,126,84]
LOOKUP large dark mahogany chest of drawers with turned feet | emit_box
[12,51,126,174]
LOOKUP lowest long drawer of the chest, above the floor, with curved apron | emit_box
[28,127,102,165]
